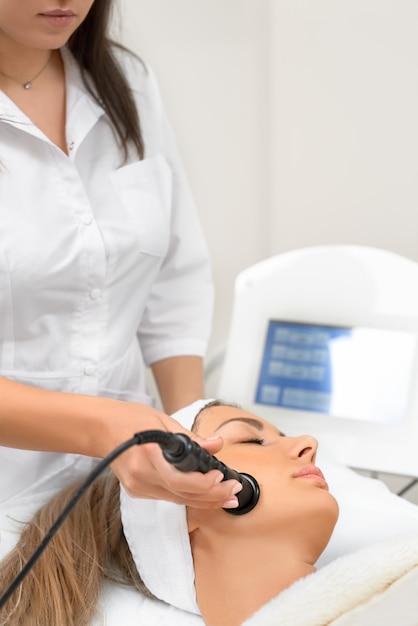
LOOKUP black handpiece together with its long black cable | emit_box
[0,430,260,609]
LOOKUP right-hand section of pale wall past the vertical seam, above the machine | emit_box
[270,0,418,260]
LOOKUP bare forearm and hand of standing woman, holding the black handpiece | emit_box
[0,376,241,508]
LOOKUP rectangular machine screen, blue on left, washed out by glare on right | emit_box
[255,321,416,423]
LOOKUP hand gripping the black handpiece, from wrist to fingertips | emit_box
[103,403,242,508]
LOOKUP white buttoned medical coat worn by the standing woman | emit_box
[0,49,213,508]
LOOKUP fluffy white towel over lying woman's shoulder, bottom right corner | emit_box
[243,532,418,626]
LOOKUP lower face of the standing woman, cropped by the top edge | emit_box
[0,0,94,50]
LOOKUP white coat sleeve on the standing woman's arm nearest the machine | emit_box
[134,66,214,364]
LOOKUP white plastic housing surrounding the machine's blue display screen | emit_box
[217,245,418,476]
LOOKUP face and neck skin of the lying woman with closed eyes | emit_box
[187,405,338,626]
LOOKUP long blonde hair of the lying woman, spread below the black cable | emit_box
[0,473,152,626]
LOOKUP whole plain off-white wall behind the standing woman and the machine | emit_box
[116,0,418,366]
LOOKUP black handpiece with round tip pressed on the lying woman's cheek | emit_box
[160,433,260,515]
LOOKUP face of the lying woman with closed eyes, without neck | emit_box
[194,406,338,542]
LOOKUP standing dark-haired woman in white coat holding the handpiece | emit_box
[0,0,242,528]
